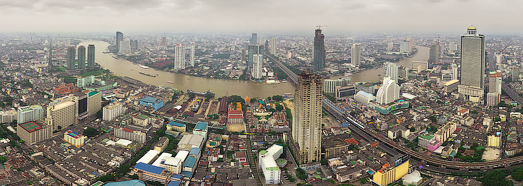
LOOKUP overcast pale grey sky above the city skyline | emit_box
[0,0,523,33]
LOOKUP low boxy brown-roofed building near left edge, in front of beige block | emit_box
[16,119,53,145]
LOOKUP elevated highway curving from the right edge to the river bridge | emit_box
[266,55,523,172]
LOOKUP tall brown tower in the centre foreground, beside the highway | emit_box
[292,69,323,163]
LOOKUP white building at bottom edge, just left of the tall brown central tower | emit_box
[259,144,283,184]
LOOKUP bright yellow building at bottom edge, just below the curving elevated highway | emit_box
[372,160,409,185]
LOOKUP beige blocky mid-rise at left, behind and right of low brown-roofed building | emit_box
[45,99,77,130]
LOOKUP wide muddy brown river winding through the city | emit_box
[80,41,429,98]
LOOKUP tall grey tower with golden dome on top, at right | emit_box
[458,26,485,102]
